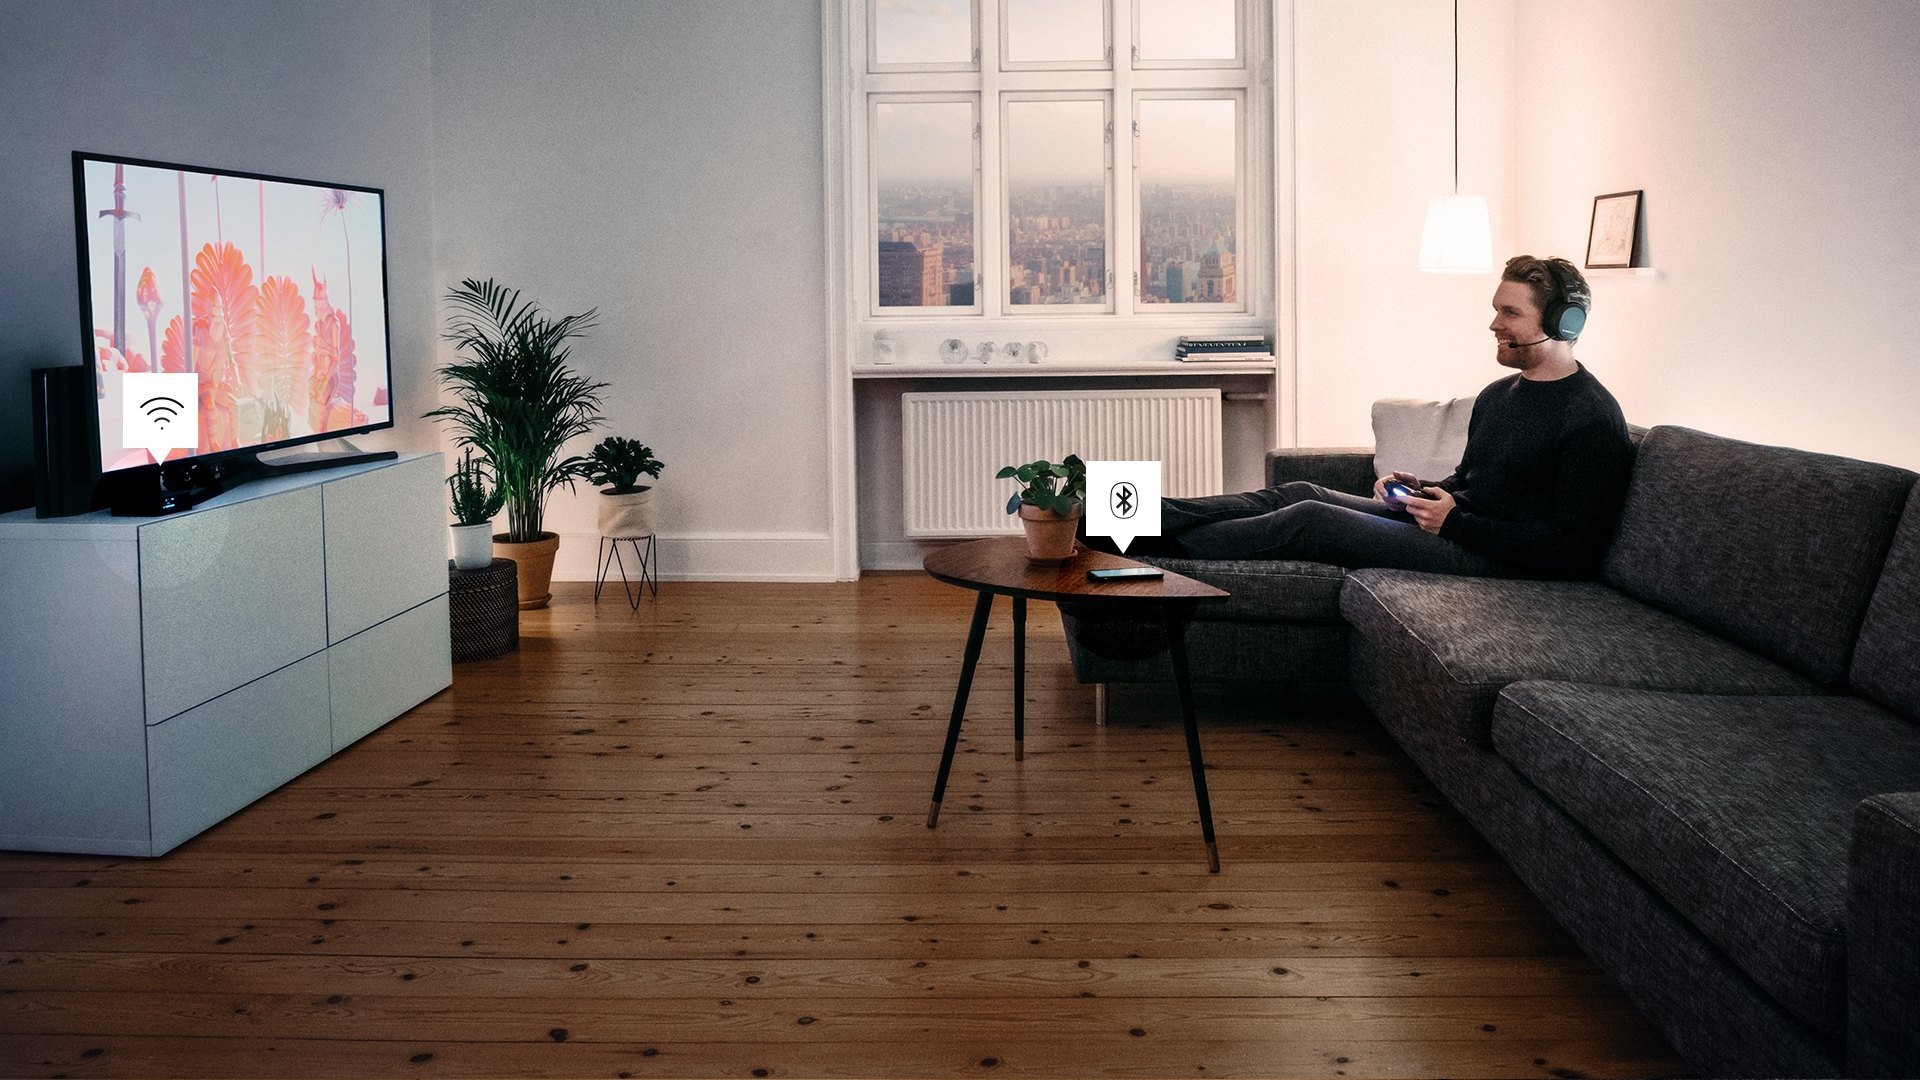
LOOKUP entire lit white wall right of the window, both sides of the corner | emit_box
[1296,0,1920,469]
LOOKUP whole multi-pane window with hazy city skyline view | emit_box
[847,0,1263,317]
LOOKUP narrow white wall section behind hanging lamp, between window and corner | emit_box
[1283,0,1512,446]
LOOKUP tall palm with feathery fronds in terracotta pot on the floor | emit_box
[426,279,607,609]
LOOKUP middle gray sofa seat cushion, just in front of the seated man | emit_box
[1340,569,1818,746]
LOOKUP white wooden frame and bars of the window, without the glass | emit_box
[840,0,1290,340]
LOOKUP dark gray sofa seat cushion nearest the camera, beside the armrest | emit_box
[1494,682,1920,1036]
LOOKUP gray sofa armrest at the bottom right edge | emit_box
[1847,792,1920,1076]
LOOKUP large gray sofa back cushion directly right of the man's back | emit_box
[1601,427,1914,690]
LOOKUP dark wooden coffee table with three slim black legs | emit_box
[924,536,1229,874]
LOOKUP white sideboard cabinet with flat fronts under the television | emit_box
[0,454,453,855]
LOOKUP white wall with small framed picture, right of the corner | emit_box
[1513,0,1920,469]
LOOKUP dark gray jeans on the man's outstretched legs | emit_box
[1142,480,1505,577]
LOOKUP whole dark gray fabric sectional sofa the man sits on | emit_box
[1062,427,1920,1076]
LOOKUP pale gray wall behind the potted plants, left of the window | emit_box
[432,0,833,578]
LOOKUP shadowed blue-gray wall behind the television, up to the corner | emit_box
[0,0,434,507]
